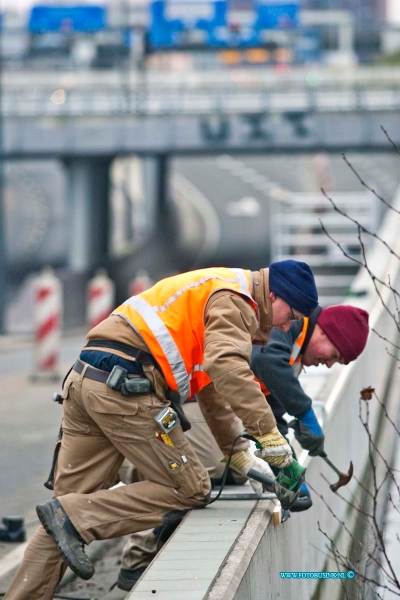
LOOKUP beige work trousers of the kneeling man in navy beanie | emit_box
[5,367,210,600]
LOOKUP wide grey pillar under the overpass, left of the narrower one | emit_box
[65,157,112,272]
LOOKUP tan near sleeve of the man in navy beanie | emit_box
[203,292,276,435]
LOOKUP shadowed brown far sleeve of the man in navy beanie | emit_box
[196,383,250,455]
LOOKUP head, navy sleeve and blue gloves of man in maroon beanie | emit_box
[251,305,369,512]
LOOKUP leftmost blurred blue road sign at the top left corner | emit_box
[28,6,106,33]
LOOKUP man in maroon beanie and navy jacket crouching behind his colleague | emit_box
[117,305,369,591]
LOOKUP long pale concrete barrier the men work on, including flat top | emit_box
[128,192,400,600]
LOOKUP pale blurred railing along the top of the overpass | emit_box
[2,70,400,117]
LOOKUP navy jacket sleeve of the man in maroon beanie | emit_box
[251,324,312,418]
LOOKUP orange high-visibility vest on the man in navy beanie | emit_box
[113,267,259,401]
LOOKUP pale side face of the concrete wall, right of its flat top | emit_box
[219,184,400,600]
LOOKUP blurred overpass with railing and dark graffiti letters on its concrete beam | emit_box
[2,68,400,158]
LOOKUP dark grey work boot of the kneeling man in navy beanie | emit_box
[36,498,94,579]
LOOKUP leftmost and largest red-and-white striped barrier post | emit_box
[32,267,63,380]
